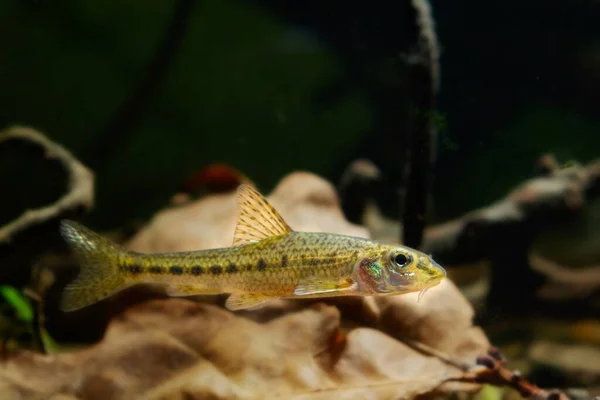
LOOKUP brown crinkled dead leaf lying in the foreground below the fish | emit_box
[0,299,478,399]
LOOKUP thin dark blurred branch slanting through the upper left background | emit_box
[84,0,197,169]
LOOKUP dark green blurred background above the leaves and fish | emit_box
[0,0,600,228]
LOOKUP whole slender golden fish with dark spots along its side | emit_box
[61,185,446,311]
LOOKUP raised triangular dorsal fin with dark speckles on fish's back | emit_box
[233,184,292,246]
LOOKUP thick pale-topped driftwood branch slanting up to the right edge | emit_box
[424,155,600,264]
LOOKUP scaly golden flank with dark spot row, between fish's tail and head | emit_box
[121,232,363,294]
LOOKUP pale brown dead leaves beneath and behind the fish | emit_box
[0,172,489,399]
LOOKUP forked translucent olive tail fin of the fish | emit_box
[60,220,127,311]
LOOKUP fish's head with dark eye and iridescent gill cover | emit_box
[353,245,446,295]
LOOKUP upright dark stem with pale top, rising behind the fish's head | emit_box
[401,0,439,248]
